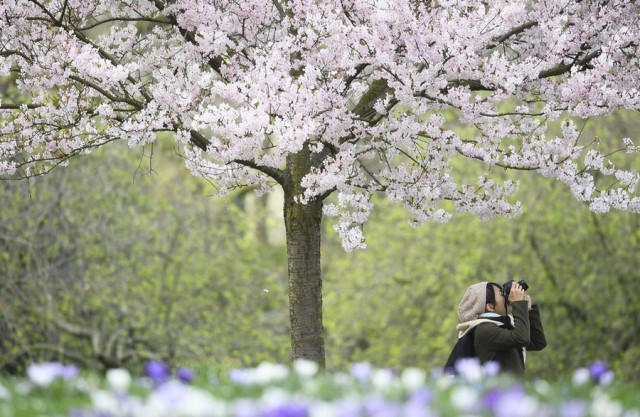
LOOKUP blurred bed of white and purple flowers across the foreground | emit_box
[0,359,640,417]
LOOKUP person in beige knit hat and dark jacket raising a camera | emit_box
[457,280,547,377]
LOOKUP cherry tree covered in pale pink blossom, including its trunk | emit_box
[0,0,640,363]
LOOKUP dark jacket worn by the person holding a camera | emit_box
[474,301,547,377]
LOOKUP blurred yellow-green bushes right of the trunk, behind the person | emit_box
[323,164,640,380]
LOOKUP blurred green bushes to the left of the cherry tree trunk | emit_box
[0,146,288,370]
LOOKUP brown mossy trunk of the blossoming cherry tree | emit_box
[284,150,325,367]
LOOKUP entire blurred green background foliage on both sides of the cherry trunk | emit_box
[0,109,640,380]
